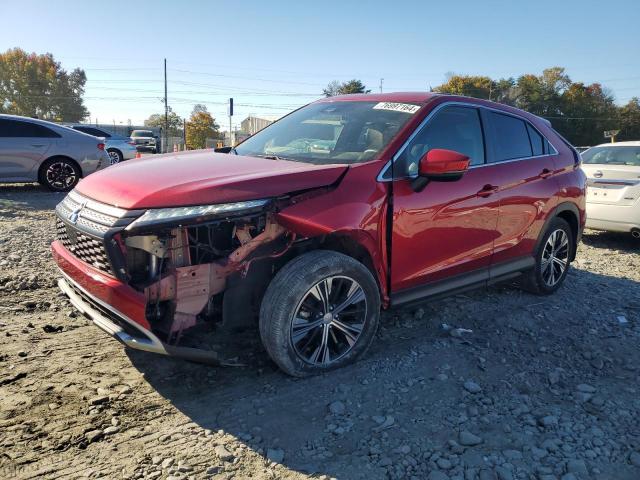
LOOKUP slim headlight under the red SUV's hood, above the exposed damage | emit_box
[126,199,270,230]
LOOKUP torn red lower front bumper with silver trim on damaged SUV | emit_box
[51,240,226,365]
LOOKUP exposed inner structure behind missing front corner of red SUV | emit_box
[116,212,296,345]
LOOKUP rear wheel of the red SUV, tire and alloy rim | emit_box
[522,217,576,295]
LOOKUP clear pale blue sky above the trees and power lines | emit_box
[0,0,640,127]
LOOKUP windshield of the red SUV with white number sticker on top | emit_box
[235,102,420,164]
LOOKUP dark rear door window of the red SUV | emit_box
[487,111,533,163]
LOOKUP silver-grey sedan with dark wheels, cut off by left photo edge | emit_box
[0,115,109,191]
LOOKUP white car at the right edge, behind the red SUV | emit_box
[582,142,640,239]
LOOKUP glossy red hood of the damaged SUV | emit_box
[76,150,348,209]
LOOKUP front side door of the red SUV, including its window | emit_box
[391,105,499,296]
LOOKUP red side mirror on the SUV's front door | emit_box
[412,148,469,191]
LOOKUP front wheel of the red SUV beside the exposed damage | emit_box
[260,250,380,377]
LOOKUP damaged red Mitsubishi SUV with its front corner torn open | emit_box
[52,93,585,376]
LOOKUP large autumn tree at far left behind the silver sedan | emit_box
[0,48,89,122]
